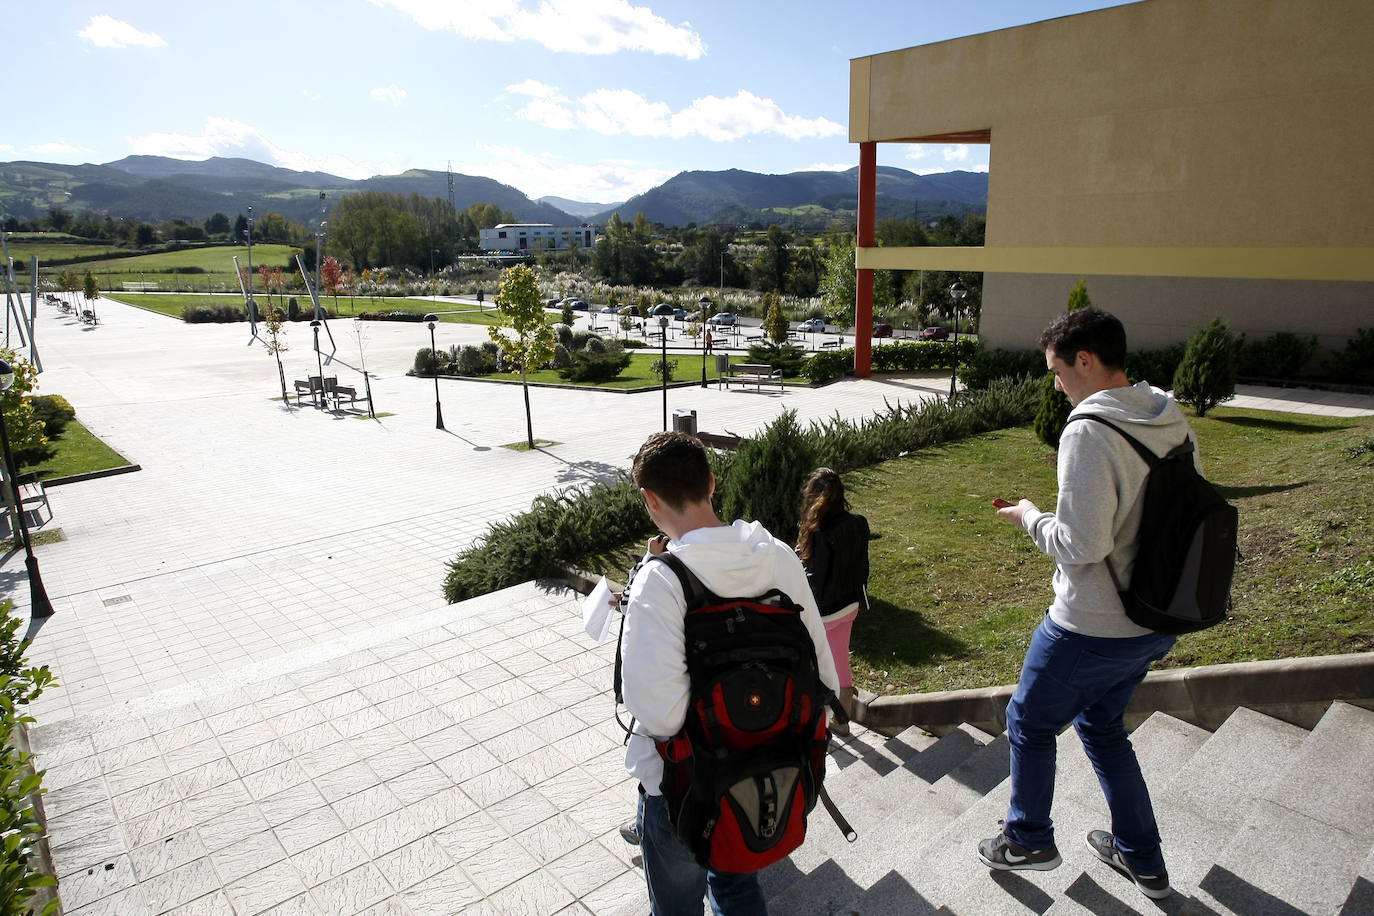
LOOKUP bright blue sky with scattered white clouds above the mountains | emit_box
[10,0,1124,203]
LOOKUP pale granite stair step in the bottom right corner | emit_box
[1198,702,1374,913]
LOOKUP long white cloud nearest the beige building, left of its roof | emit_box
[507,80,844,140]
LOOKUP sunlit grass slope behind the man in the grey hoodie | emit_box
[587,408,1374,694]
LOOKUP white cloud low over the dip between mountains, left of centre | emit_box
[453,144,677,201]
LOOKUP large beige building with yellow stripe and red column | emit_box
[849,0,1374,374]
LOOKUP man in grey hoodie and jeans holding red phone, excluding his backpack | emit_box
[978,308,1195,900]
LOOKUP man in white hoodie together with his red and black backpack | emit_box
[620,433,838,916]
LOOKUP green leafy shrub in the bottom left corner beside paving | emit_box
[0,602,58,916]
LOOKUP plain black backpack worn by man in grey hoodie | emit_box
[1069,413,1238,633]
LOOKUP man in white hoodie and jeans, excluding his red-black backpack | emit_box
[621,433,838,916]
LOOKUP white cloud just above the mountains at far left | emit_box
[125,118,408,179]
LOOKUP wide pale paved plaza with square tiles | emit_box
[0,299,1374,916]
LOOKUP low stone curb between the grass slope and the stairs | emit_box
[856,652,1374,735]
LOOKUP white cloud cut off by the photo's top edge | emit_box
[372,0,706,60]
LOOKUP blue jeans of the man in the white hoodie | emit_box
[638,792,768,916]
